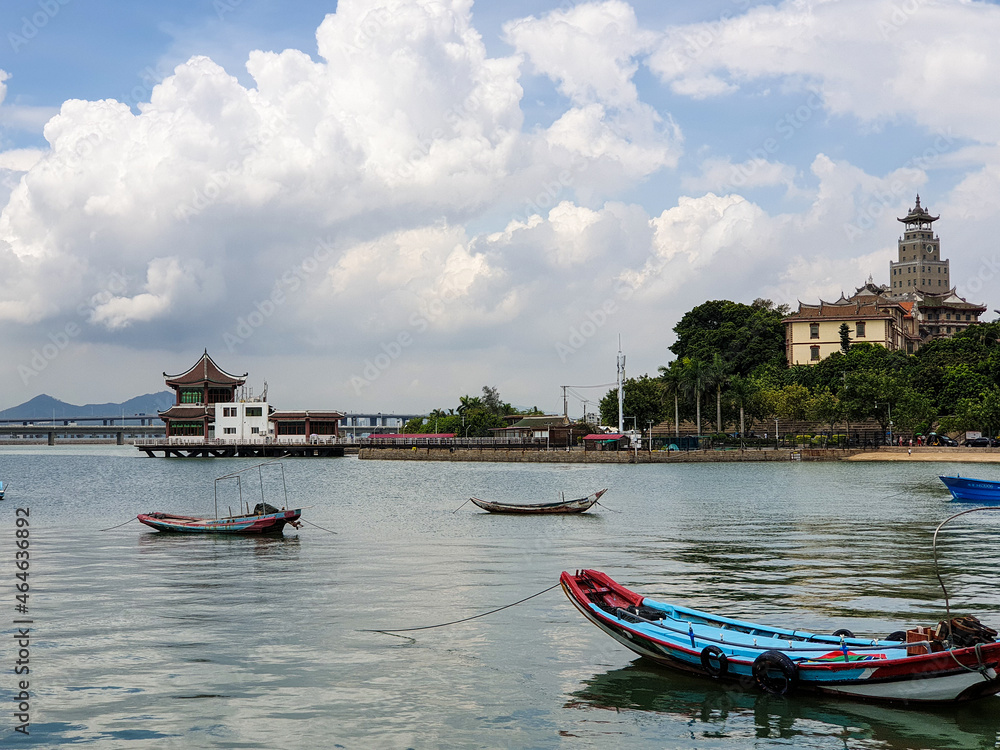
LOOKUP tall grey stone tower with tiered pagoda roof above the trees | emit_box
[889,195,951,297]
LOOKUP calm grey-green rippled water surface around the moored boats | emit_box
[0,447,1000,749]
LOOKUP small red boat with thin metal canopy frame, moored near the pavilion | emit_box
[136,461,302,534]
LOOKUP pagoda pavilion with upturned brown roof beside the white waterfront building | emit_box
[159,349,248,440]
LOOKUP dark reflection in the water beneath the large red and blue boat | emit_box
[565,659,1000,750]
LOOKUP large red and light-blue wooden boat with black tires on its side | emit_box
[560,570,1000,704]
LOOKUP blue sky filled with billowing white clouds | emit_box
[0,0,1000,416]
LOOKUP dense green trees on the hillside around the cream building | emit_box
[660,300,1000,434]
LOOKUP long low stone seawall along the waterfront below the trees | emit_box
[358,447,861,464]
